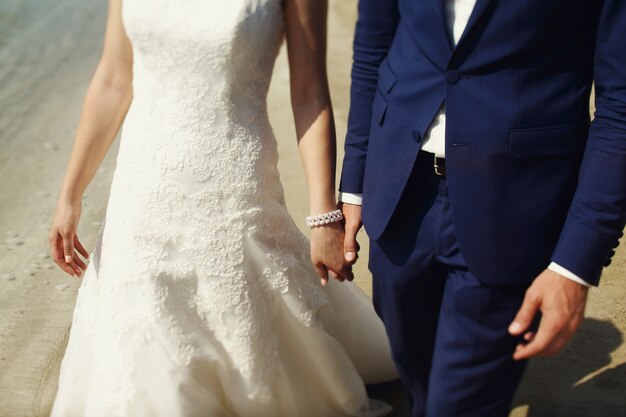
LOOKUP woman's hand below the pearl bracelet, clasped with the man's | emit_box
[311,222,354,285]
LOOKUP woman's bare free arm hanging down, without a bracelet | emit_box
[49,0,132,276]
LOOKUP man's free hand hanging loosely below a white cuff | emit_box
[509,269,589,360]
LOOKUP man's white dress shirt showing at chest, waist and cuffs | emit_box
[339,0,591,287]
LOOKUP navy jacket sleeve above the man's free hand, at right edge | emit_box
[552,0,626,285]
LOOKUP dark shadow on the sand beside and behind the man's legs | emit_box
[368,318,626,417]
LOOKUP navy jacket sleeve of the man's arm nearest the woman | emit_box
[339,0,400,194]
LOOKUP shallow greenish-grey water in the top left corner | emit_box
[0,0,106,145]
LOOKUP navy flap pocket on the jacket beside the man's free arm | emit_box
[509,123,588,158]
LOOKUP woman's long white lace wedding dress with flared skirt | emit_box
[52,0,396,417]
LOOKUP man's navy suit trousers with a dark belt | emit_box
[369,152,527,417]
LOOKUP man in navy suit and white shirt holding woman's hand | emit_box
[340,0,626,417]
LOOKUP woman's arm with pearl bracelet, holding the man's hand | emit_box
[284,0,353,284]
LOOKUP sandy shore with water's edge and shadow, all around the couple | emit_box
[0,0,626,417]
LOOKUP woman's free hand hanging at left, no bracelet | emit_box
[48,201,89,276]
